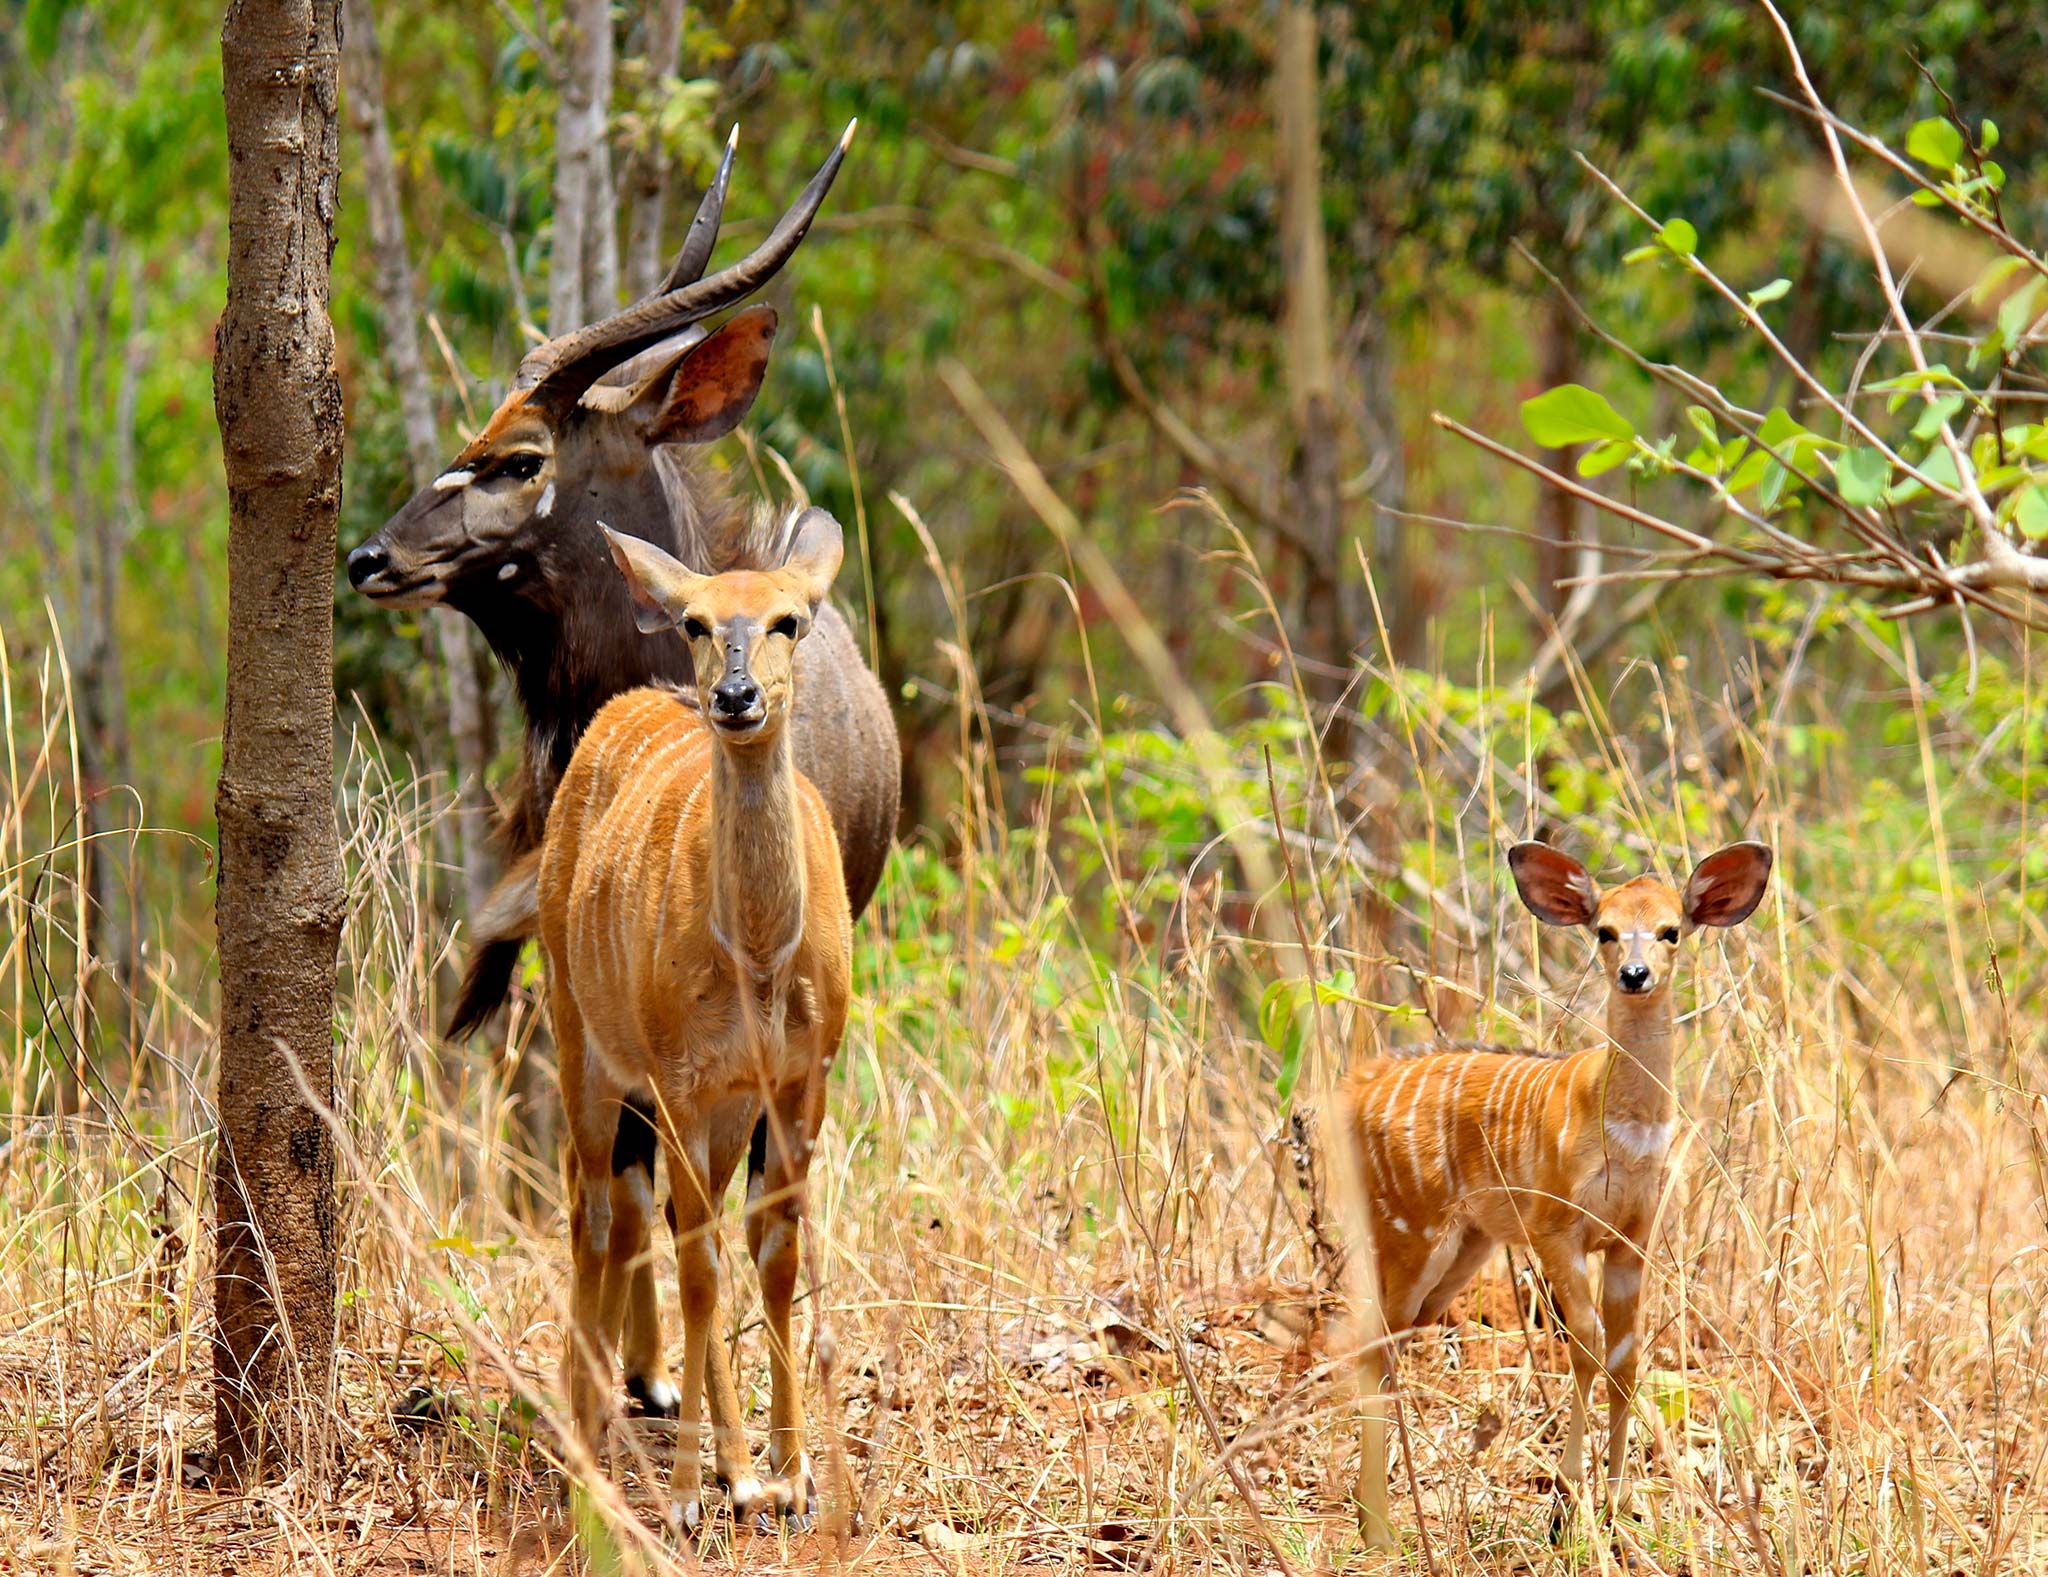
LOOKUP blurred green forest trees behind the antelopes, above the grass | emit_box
[0,0,2048,1056]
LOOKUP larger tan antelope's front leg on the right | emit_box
[748,1081,813,1526]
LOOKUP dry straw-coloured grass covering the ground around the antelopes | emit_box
[0,522,2048,1577]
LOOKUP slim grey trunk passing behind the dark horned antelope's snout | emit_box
[342,0,496,918]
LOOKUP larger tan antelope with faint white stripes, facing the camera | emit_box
[537,510,852,1528]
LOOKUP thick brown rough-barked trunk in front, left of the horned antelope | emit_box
[213,0,342,1479]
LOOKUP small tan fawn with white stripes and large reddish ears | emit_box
[1341,844,1772,1546]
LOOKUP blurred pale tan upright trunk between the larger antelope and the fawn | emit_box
[1274,4,1354,762]
